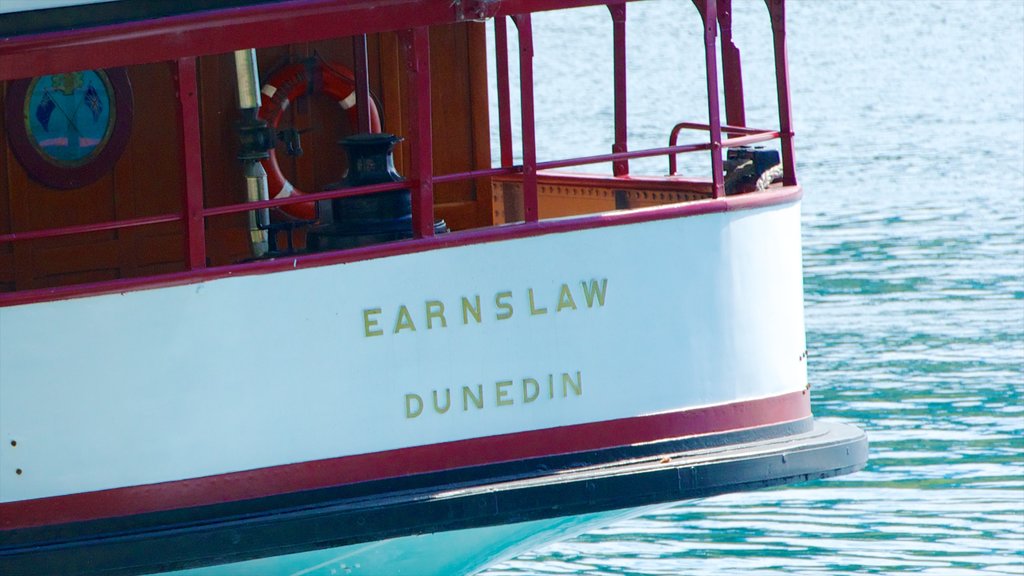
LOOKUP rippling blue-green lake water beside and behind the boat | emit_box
[485,0,1024,576]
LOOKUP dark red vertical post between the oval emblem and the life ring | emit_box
[174,57,206,270]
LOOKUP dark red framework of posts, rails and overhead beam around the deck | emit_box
[0,0,796,305]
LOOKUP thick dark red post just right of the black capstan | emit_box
[399,27,434,238]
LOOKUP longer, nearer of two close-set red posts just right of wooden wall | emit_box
[512,14,540,222]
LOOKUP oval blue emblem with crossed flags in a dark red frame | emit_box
[6,69,132,189]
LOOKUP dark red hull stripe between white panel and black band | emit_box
[0,392,811,530]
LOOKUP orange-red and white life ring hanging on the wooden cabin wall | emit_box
[259,58,381,220]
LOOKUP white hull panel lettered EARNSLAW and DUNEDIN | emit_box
[0,204,806,501]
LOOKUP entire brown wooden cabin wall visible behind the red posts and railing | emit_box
[0,23,493,291]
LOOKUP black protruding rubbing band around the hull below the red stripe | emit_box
[0,421,867,576]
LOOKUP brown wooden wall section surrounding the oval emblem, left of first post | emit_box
[0,64,183,290]
